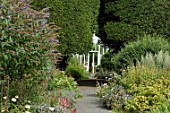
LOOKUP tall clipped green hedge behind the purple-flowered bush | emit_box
[32,0,100,54]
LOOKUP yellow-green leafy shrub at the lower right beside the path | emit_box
[122,65,170,111]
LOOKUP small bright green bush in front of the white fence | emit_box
[65,58,88,80]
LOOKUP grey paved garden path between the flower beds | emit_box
[76,86,109,113]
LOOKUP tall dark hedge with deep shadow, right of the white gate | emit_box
[99,0,170,49]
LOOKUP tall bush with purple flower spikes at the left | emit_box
[0,0,57,79]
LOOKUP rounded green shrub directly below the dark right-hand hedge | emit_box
[112,35,170,73]
